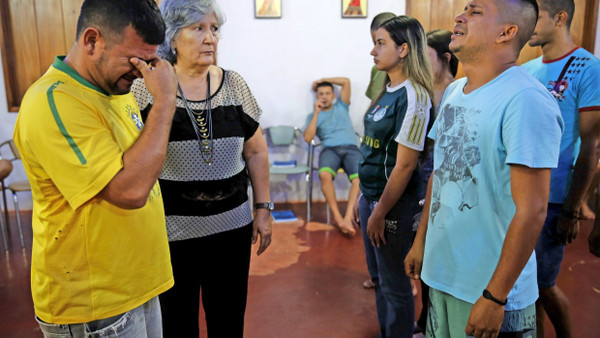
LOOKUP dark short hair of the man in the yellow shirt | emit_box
[76,0,165,45]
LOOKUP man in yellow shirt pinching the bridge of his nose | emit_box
[14,0,177,337]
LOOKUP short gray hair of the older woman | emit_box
[157,0,225,64]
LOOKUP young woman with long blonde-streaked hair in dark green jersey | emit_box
[358,16,434,337]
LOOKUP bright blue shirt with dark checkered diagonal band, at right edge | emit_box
[523,48,600,203]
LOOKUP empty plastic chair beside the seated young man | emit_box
[264,126,314,222]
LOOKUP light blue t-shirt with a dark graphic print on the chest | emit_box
[422,67,563,311]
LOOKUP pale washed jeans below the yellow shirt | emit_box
[35,297,162,338]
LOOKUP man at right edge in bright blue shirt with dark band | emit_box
[523,0,600,337]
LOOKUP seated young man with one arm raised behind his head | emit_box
[304,77,362,236]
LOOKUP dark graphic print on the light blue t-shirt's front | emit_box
[431,104,481,224]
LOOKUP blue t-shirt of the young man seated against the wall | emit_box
[303,98,358,148]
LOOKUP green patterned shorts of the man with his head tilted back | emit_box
[426,288,536,338]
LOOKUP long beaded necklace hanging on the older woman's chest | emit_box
[177,73,213,165]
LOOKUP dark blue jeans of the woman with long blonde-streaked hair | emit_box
[358,196,415,337]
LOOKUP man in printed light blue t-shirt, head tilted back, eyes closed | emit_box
[405,0,563,337]
